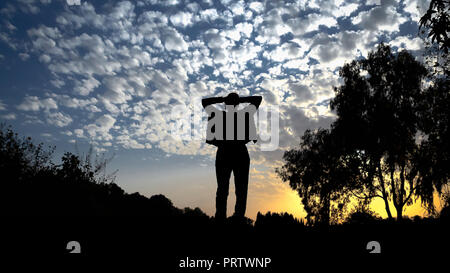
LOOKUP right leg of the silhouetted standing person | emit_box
[233,148,250,218]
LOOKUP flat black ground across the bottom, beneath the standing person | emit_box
[3,193,450,272]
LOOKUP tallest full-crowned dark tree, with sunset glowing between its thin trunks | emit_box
[331,44,427,220]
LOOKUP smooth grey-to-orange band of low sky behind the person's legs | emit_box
[117,160,440,220]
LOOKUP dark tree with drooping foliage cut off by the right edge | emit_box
[416,0,450,213]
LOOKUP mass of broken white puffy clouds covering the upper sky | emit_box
[0,0,424,164]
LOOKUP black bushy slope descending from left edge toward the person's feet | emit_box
[0,125,210,244]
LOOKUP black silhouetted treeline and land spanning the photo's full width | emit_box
[0,126,450,264]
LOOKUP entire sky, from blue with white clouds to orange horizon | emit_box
[0,0,429,219]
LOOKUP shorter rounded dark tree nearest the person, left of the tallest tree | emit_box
[276,129,367,225]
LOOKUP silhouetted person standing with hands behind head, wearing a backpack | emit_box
[202,93,262,221]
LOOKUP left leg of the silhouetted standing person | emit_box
[215,148,231,220]
